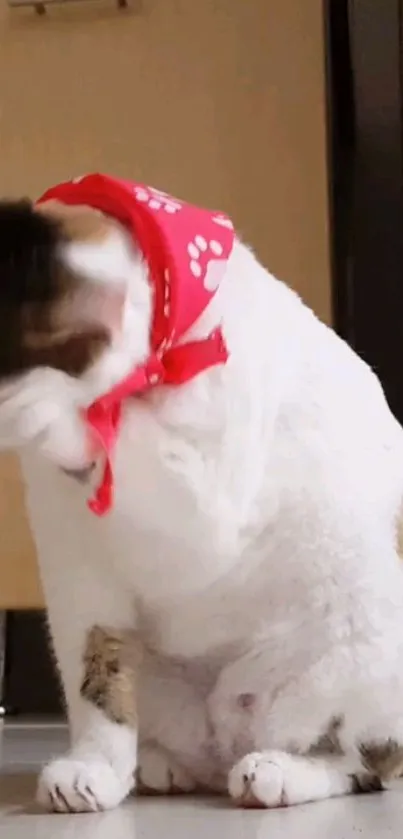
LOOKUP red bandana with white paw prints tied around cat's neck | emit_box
[38,175,234,516]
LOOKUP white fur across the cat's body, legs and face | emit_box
[0,223,403,810]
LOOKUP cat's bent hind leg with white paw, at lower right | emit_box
[209,646,403,807]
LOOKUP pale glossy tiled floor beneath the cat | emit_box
[0,724,403,839]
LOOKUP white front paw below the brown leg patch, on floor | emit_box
[37,757,134,813]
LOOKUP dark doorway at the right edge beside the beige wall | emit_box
[325,0,403,421]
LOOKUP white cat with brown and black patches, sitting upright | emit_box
[0,179,403,812]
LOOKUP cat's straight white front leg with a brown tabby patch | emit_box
[38,549,138,812]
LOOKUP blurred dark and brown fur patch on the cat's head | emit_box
[0,201,113,380]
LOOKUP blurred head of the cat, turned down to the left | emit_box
[0,201,151,471]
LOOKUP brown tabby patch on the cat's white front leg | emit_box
[81,626,140,728]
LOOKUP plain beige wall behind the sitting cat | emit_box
[0,0,330,607]
